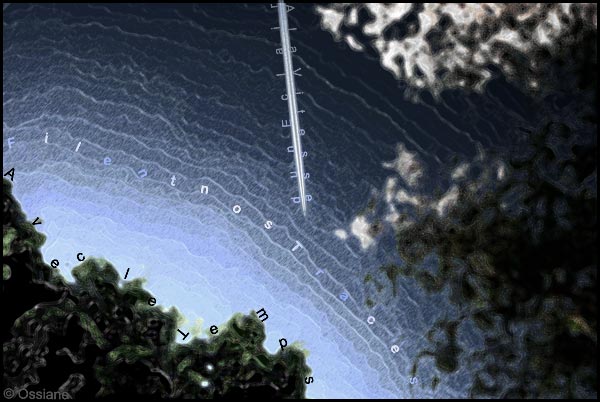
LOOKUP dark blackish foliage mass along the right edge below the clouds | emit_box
[398,123,597,397]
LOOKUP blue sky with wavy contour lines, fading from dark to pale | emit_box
[3,4,536,398]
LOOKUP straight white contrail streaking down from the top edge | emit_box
[278,0,306,216]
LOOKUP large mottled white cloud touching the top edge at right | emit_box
[315,3,597,95]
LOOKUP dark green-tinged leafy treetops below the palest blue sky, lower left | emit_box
[2,180,309,398]
